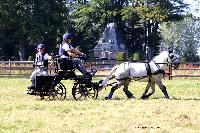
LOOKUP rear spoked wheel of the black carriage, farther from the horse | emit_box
[48,82,66,100]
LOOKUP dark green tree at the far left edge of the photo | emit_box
[0,0,28,58]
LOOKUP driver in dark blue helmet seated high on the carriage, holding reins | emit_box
[59,33,96,78]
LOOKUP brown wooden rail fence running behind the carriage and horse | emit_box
[0,61,200,79]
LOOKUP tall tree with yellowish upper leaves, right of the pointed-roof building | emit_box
[121,0,186,55]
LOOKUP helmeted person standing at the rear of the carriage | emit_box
[27,44,51,94]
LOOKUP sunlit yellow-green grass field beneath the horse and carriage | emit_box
[0,78,200,133]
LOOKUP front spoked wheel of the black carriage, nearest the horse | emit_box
[72,83,98,100]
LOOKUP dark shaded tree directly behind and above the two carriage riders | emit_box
[28,0,71,55]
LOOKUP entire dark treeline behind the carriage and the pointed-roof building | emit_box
[0,0,188,59]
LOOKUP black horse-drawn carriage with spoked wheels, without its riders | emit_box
[29,57,99,100]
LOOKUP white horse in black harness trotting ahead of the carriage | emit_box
[99,51,179,99]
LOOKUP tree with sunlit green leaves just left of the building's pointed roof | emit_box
[72,0,129,53]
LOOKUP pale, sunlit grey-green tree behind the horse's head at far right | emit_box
[161,16,200,62]
